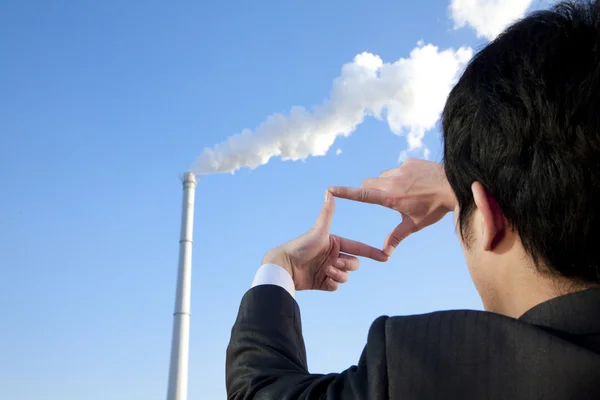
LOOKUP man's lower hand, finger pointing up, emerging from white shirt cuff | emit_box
[263,191,388,291]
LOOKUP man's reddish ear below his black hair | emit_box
[471,182,506,251]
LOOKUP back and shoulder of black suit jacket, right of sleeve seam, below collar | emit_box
[385,310,600,399]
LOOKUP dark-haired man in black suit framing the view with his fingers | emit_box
[226,2,600,400]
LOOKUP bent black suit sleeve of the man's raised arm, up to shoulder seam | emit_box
[226,285,388,400]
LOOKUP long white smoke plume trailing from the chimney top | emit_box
[190,42,473,174]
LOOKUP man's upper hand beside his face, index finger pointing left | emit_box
[329,159,456,256]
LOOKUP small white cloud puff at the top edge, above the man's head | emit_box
[449,0,532,40]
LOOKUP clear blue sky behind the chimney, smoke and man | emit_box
[0,0,536,400]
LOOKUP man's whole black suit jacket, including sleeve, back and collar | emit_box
[226,285,600,400]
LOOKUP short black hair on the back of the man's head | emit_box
[443,0,600,284]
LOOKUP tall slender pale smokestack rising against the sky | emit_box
[167,172,196,400]
